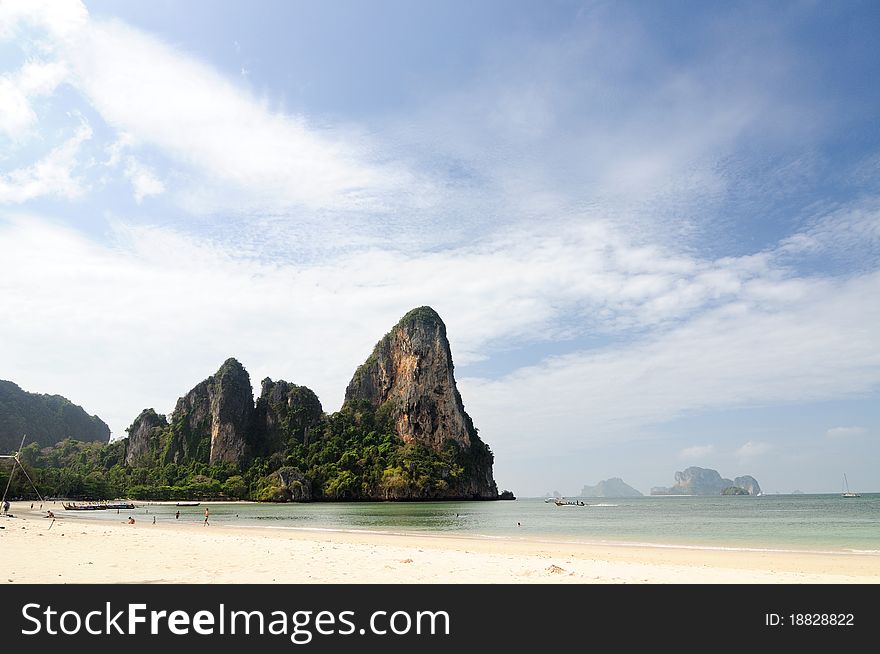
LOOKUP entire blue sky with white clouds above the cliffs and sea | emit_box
[0,0,880,497]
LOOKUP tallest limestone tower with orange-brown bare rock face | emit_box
[343,307,498,499]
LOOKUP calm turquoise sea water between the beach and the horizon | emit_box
[56,493,880,555]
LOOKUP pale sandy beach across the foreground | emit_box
[0,502,880,584]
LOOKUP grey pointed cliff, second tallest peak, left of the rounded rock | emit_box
[168,359,254,464]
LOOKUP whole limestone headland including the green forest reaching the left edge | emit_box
[0,307,514,502]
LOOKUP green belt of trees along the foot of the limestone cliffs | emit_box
[0,410,492,501]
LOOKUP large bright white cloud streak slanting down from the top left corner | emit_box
[0,2,435,218]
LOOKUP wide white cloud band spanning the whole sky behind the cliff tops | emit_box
[0,217,880,452]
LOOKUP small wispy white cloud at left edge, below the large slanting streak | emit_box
[0,124,92,204]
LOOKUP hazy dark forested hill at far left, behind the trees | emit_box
[0,380,110,454]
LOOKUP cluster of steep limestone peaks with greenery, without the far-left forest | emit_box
[117,307,498,501]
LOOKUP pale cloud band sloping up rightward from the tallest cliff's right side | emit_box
[461,273,880,458]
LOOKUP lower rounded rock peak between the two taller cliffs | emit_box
[254,377,324,453]
